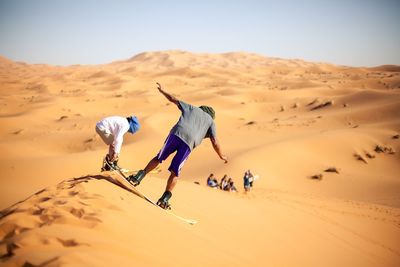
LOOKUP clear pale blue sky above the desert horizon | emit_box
[0,0,400,66]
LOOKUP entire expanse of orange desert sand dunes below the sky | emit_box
[0,51,400,266]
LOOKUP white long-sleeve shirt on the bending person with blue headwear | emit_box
[97,116,130,154]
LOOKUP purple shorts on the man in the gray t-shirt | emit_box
[157,134,191,176]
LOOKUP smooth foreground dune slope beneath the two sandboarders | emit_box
[0,173,400,266]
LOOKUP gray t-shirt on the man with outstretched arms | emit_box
[170,101,217,150]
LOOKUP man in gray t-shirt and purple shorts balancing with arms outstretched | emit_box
[128,83,228,209]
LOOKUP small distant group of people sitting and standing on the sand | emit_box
[207,170,254,192]
